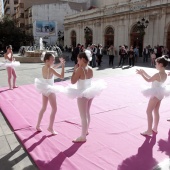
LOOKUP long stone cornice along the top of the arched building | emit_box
[65,0,170,23]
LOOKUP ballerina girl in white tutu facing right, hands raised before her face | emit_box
[35,53,65,135]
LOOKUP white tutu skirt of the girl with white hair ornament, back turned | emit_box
[64,79,107,99]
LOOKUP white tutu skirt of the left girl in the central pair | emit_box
[34,76,64,97]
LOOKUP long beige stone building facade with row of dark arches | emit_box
[64,0,170,49]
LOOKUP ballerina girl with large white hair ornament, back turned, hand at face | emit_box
[66,50,106,142]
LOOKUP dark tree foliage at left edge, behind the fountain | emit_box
[0,16,33,51]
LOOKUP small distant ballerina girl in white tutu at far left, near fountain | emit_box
[1,45,20,90]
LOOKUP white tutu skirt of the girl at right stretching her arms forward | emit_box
[142,81,170,100]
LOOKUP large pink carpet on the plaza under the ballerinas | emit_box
[0,75,170,170]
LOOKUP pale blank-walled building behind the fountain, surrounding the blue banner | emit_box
[31,0,90,45]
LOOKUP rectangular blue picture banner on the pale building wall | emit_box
[35,21,56,36]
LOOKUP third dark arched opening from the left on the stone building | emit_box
[105,27,114,47]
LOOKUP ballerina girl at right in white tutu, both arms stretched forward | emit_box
[136,56,170,136]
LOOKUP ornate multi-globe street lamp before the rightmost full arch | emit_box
[137,18,149,54]
